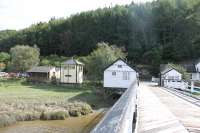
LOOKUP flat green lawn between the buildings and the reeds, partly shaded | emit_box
[0,79,110,109]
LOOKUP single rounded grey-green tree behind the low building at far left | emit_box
[10,45,40,72]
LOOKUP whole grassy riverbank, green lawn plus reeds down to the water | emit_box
[0,79,113,127]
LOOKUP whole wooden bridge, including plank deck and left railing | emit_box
[91,81,200,133]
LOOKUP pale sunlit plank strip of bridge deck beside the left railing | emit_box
[137,84,188,133]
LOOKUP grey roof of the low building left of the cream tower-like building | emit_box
[27,66,54,73]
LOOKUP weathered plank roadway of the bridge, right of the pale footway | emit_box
[150,84,200,133]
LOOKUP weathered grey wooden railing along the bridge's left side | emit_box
[91,81,138,133]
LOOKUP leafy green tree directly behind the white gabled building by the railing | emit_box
[83,42,126,81]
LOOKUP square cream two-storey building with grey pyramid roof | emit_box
[60,58,83,83]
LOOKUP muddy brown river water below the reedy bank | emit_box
[0,112,104,133]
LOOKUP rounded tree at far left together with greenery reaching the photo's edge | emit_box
[0,45,40,72]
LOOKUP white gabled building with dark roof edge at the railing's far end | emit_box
[104,58,137,88]
